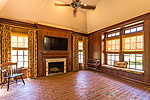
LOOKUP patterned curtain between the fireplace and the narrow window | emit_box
[73,35,79,71]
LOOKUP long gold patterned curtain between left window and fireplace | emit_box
[28,30,37,78]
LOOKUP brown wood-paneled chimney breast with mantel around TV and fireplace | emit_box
[36,24,72,76]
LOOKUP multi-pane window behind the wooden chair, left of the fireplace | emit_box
[11,35,28,67]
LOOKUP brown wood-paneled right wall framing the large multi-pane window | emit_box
[89,13,150,85]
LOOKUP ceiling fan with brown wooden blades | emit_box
[55,0,96,16]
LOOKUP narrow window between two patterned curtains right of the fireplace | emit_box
[78,41,83,63]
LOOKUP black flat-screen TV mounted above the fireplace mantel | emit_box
[44,36,68,51]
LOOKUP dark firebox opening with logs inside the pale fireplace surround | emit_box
[48,62,64,74]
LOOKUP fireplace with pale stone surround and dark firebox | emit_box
[46,58,66,76]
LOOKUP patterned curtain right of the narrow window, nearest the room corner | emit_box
[83,37,88,69]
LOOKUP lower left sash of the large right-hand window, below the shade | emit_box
[107,54,119,65]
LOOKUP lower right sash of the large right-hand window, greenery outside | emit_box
[124,54,143,70]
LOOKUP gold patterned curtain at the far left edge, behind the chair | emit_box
[0,25,11,63]
